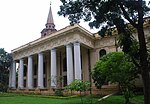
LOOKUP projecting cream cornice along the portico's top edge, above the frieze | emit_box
[11,24,94,53]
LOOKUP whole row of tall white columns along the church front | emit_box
[9,42,81,89]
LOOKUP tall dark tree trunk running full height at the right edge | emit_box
[137,0,150,104]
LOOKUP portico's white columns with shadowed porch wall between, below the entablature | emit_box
[11,38,92,89]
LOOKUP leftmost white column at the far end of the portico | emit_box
[11,61,16,89]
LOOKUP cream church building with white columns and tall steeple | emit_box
[9,3,150,94]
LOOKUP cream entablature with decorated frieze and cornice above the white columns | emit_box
[12,24,94,59]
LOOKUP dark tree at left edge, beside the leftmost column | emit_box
[0,48,12,91]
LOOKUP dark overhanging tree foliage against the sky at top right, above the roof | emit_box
[58,0,150,30]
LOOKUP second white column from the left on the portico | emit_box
[18,59,24,89]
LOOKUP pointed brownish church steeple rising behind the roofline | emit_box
[41,4,57,37]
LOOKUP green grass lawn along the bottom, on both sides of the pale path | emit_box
[0,94,144,104]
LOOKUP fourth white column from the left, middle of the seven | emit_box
[38,53,44,89]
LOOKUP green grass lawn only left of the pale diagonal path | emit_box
[0,95,98,104]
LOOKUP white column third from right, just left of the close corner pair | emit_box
[51,49,57,88]
